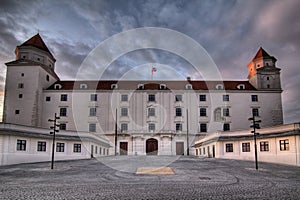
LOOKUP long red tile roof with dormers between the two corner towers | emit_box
[47,80,256,90]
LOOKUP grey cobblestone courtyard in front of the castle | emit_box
[0,156,300,199]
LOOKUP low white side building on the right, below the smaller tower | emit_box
[194,123,300,166]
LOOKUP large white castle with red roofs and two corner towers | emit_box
[3,34,283,155]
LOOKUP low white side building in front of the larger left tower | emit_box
[0,124,110,165]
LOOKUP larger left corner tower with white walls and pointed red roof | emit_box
[3,34,59,127]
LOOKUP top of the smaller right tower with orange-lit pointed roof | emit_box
[248,47,281,90]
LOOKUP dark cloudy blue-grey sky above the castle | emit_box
[0,0,300,123]
